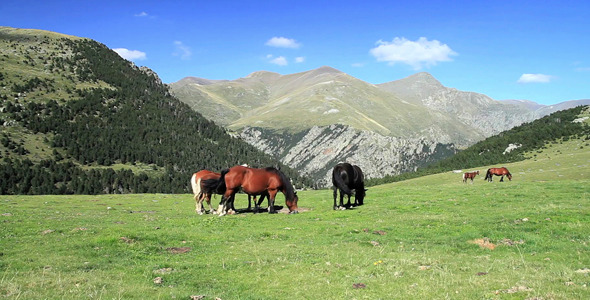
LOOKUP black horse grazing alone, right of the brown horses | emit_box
[332,163,367,210]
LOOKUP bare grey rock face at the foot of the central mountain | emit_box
[240,125,455,187]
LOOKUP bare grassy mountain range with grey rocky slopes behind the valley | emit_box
[170,66,588,186]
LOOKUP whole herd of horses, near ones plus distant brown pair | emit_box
[191,163,512,216]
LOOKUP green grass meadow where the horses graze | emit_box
[0,141,590,300]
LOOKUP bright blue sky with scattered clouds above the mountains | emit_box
[0,0,590,104]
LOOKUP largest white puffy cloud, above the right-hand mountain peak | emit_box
[369,37,458,70]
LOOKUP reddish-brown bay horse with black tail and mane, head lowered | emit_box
[204,166,299,216]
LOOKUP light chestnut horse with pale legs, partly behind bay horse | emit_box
[191,170,266,215]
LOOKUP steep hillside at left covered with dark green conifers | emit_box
[0,27,309,194]
